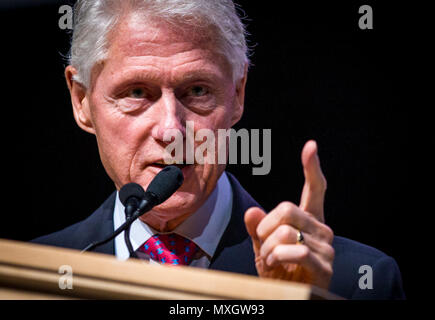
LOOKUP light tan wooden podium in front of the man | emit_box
[0,239,338,300]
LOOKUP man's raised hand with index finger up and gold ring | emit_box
[245,140,334,289]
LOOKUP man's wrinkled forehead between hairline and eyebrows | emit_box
[107,13,231,88]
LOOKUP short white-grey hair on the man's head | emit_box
[68,0,249,88]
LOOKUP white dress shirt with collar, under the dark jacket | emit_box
[113,172,233,268]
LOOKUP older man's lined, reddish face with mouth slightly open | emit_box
[66,15,246,225]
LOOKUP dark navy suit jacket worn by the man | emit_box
[32,174,405,299]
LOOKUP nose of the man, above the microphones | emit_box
[152,90,186,144]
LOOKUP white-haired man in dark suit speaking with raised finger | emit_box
[30,0,404,299]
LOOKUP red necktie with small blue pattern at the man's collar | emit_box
[138,233,199,265]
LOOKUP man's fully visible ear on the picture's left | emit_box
[65,66,95,134]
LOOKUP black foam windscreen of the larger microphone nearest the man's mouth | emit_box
[147,166,184,205]
